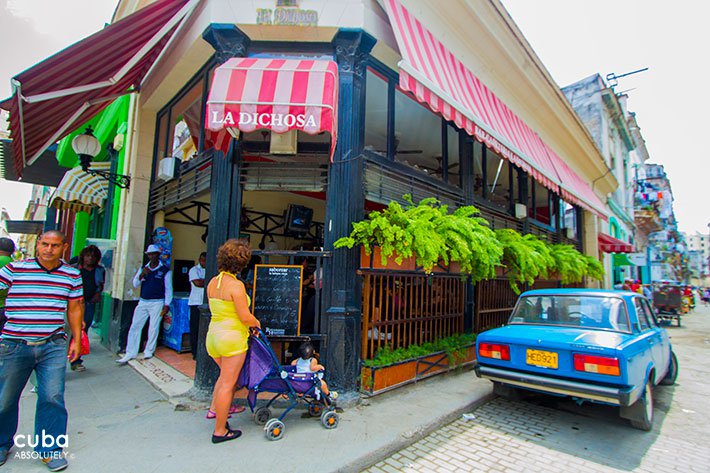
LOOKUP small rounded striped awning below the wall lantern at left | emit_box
[49,162,111,212]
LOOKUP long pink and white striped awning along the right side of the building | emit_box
[385,0,606,218]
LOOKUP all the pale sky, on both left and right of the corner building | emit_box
[0,0,710,233]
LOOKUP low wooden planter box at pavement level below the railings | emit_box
[360,344,476,396]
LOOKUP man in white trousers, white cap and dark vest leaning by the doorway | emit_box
[116,245,173,364]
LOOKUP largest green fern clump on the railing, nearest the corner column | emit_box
[334,195,503,282]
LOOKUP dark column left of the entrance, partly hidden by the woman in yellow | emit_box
[195,23,250,395]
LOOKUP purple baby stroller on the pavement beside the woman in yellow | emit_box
[238,330,340,440]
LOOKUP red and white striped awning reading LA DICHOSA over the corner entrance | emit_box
[205,58,338,157]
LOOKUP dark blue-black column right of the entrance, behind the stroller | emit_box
[324,29,376,394]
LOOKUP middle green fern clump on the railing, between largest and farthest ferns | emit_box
[495,228,555,294]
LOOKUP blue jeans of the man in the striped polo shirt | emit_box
[0,338,67,454]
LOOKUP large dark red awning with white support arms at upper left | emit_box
[0,0,198,174]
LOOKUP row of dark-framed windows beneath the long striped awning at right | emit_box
[365,58,579,223]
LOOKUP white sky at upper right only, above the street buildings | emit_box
[502,0,710,233]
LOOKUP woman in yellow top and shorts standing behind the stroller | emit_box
[205,239,261,443]
